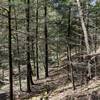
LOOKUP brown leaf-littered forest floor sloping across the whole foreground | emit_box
[0,66,100,100]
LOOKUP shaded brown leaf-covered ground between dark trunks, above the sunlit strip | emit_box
[21,67,69,98]
